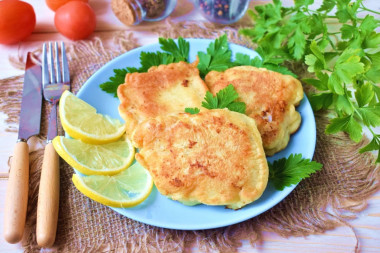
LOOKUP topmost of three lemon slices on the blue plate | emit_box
[59,91,125,144]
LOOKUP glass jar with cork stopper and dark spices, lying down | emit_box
[111,0,177,25]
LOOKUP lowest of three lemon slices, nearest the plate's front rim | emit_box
[73,163,153,207]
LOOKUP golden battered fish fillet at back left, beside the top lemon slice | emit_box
[117,62,208,136]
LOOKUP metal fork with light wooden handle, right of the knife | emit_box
[36,42,70,247]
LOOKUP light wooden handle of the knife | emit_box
[4,142,29,243]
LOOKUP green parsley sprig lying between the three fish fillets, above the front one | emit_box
[185,84,246,114]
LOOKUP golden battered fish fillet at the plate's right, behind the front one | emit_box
[205,66,303,156]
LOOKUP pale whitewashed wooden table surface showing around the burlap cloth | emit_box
[0,0,380,253]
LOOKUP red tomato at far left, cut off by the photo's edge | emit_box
[0,0,36,44]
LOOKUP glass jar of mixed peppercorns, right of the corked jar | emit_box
[194,0,249,24]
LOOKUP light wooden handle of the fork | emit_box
[37,143,59,247]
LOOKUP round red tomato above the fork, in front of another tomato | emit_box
[54,1,96,40]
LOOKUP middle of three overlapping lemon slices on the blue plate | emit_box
[53,136,135,175]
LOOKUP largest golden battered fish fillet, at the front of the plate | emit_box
[132,109,268,209]
